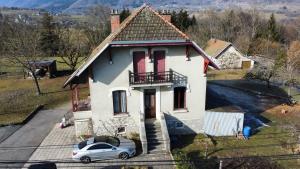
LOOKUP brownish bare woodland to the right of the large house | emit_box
[186,9,300,94]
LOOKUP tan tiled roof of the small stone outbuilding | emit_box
[204,39,231,58]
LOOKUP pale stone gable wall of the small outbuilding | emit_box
[217,46,250,69]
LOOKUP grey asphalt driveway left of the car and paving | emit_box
[0,103,68,168]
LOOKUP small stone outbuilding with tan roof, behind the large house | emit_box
[205,39,254,69]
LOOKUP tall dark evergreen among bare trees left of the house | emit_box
[39,13,59,56]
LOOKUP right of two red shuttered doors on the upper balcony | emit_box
[154,51,166,80]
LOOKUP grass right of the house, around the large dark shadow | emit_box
[173,70,300,169]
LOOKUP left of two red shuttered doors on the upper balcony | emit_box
[133,51,146,81]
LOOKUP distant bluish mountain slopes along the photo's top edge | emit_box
[0,0,300,13]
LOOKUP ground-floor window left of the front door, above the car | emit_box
[113,90,127,114]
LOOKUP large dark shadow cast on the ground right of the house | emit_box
[206,80,288,132]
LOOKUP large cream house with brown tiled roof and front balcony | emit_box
[64,5,218,153]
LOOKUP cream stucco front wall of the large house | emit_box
[89,46,206,134]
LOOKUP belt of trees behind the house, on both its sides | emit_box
[0,6,300,95]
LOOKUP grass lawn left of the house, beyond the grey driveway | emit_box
[0,77,88,125]
